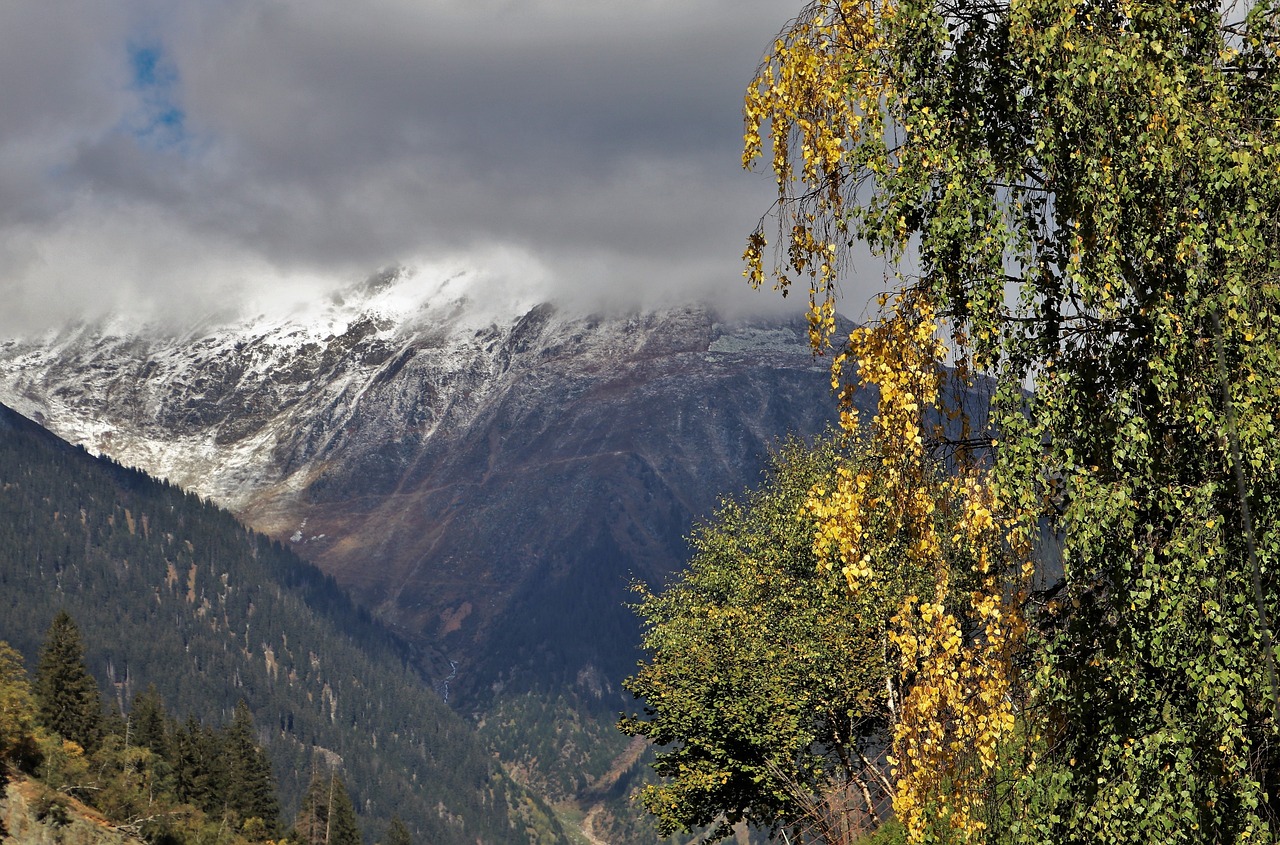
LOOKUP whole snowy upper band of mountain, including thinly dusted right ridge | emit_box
[0,273,819,510]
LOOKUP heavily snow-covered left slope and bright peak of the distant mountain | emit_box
[0,263,540,512]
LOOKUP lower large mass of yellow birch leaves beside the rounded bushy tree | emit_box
[808,292,1032,842]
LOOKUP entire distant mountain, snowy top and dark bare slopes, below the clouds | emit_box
[0,273,860,696]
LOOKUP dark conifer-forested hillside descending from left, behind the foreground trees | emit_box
[0,406,562,842]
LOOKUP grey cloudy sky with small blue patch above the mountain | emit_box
[0,0,860,332]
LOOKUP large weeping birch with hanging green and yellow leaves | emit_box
[745,0,1280,842]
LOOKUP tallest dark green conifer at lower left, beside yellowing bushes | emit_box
[35,611,102,752]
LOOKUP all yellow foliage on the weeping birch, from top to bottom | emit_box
[742,0,1032,842]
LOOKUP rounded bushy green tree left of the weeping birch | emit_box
[620,440,947,844]
